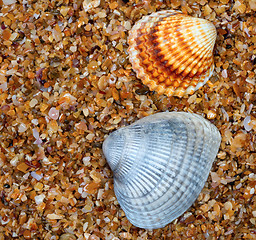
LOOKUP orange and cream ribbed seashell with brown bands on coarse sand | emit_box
[128,10,216,97]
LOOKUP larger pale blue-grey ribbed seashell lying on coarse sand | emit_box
[103,112,221,229]
